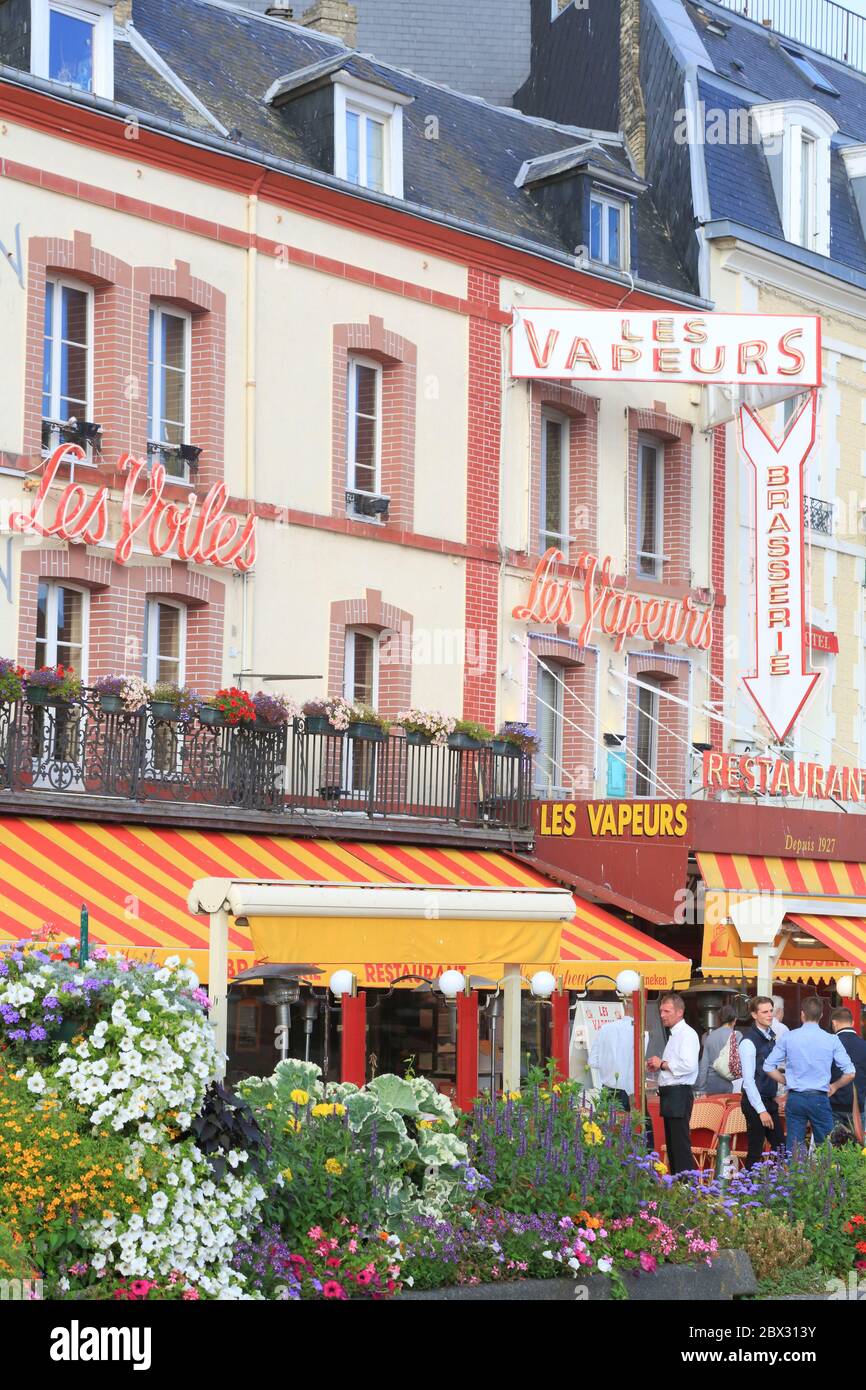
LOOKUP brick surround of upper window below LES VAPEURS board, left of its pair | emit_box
[530,381,599,559]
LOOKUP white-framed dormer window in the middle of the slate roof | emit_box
[331,71,411,197]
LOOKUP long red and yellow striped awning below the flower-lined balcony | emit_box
[0,816,691,988]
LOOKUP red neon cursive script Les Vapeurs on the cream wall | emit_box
[512,548,713,652]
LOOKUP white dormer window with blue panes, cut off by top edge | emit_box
[31,0,114,100]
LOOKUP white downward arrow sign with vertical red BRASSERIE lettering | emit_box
[740,392,822,744]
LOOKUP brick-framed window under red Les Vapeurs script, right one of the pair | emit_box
[627,652,691,796]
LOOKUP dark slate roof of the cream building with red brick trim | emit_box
[0,0,694,296]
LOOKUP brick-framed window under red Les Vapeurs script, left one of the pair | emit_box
[527,637,598,796]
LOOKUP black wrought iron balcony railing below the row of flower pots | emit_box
[0,689,532,831]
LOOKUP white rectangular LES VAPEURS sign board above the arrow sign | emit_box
[512,307,822,386]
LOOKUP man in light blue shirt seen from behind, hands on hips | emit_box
[763,998,855,1150]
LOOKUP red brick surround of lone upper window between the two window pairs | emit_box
[331,316,417,531]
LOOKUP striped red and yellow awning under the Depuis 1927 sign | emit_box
[696,853,866,999]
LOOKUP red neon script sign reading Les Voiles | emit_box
[10,445,256,570]
